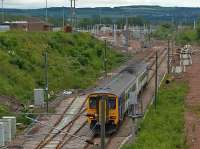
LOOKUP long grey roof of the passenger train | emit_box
[92,62,147,96]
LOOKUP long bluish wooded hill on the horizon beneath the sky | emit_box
[2,6,200,23]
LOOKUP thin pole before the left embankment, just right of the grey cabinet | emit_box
[44,51,49,113]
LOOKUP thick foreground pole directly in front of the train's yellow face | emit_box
[100,96,106,149]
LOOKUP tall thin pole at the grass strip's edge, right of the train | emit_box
[154,50,158,110]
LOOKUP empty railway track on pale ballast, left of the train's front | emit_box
[36,96,86,149]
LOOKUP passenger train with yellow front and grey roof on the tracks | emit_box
[87,62,148,131]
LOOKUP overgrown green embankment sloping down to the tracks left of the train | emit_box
[0,31,125,122]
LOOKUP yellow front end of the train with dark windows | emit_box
[87,93,119,133]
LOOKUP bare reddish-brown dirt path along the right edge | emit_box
[185,52,200,149]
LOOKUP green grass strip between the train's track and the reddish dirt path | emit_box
[124,81,188,149]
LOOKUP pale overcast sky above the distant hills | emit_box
[4,0,200,8]
